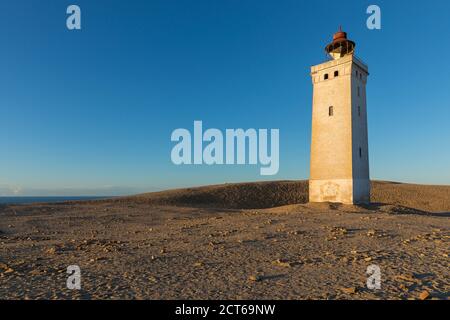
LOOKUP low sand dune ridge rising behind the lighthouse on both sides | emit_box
[121,180,450,212]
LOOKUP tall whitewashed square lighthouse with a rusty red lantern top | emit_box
[309,28,370,204]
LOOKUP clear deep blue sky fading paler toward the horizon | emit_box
[0,0,450,195]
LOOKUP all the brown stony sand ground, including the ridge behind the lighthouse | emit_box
[0,182,450,299]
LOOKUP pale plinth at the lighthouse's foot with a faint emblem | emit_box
[309,179,370,204]
